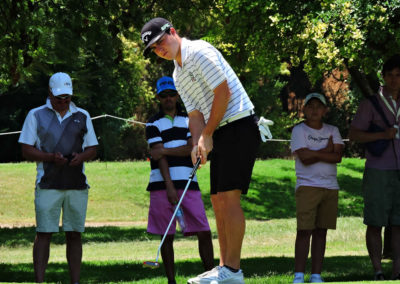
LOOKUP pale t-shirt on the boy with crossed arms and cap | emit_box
[290,123,344,189]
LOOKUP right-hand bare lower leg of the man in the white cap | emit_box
[65,232,82,283]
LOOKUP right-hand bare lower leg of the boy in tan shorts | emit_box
[311,228,327,274]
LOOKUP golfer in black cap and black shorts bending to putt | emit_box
[141,18,260,283]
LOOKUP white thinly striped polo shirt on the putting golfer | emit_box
[173,38,254,123]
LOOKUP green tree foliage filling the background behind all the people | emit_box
[0,0,400,161]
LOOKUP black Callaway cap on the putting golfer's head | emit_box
[141,18,172,56]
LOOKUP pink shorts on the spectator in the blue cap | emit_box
[147,190,210,236]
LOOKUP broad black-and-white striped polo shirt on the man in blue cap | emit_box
[146,107,199,191]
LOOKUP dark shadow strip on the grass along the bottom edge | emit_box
[0,256,390,283]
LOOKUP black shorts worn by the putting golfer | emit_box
[210,115,261,194]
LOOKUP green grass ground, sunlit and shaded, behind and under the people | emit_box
[0,159,390,283]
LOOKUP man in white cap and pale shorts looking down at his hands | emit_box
[18,72,98,283]
